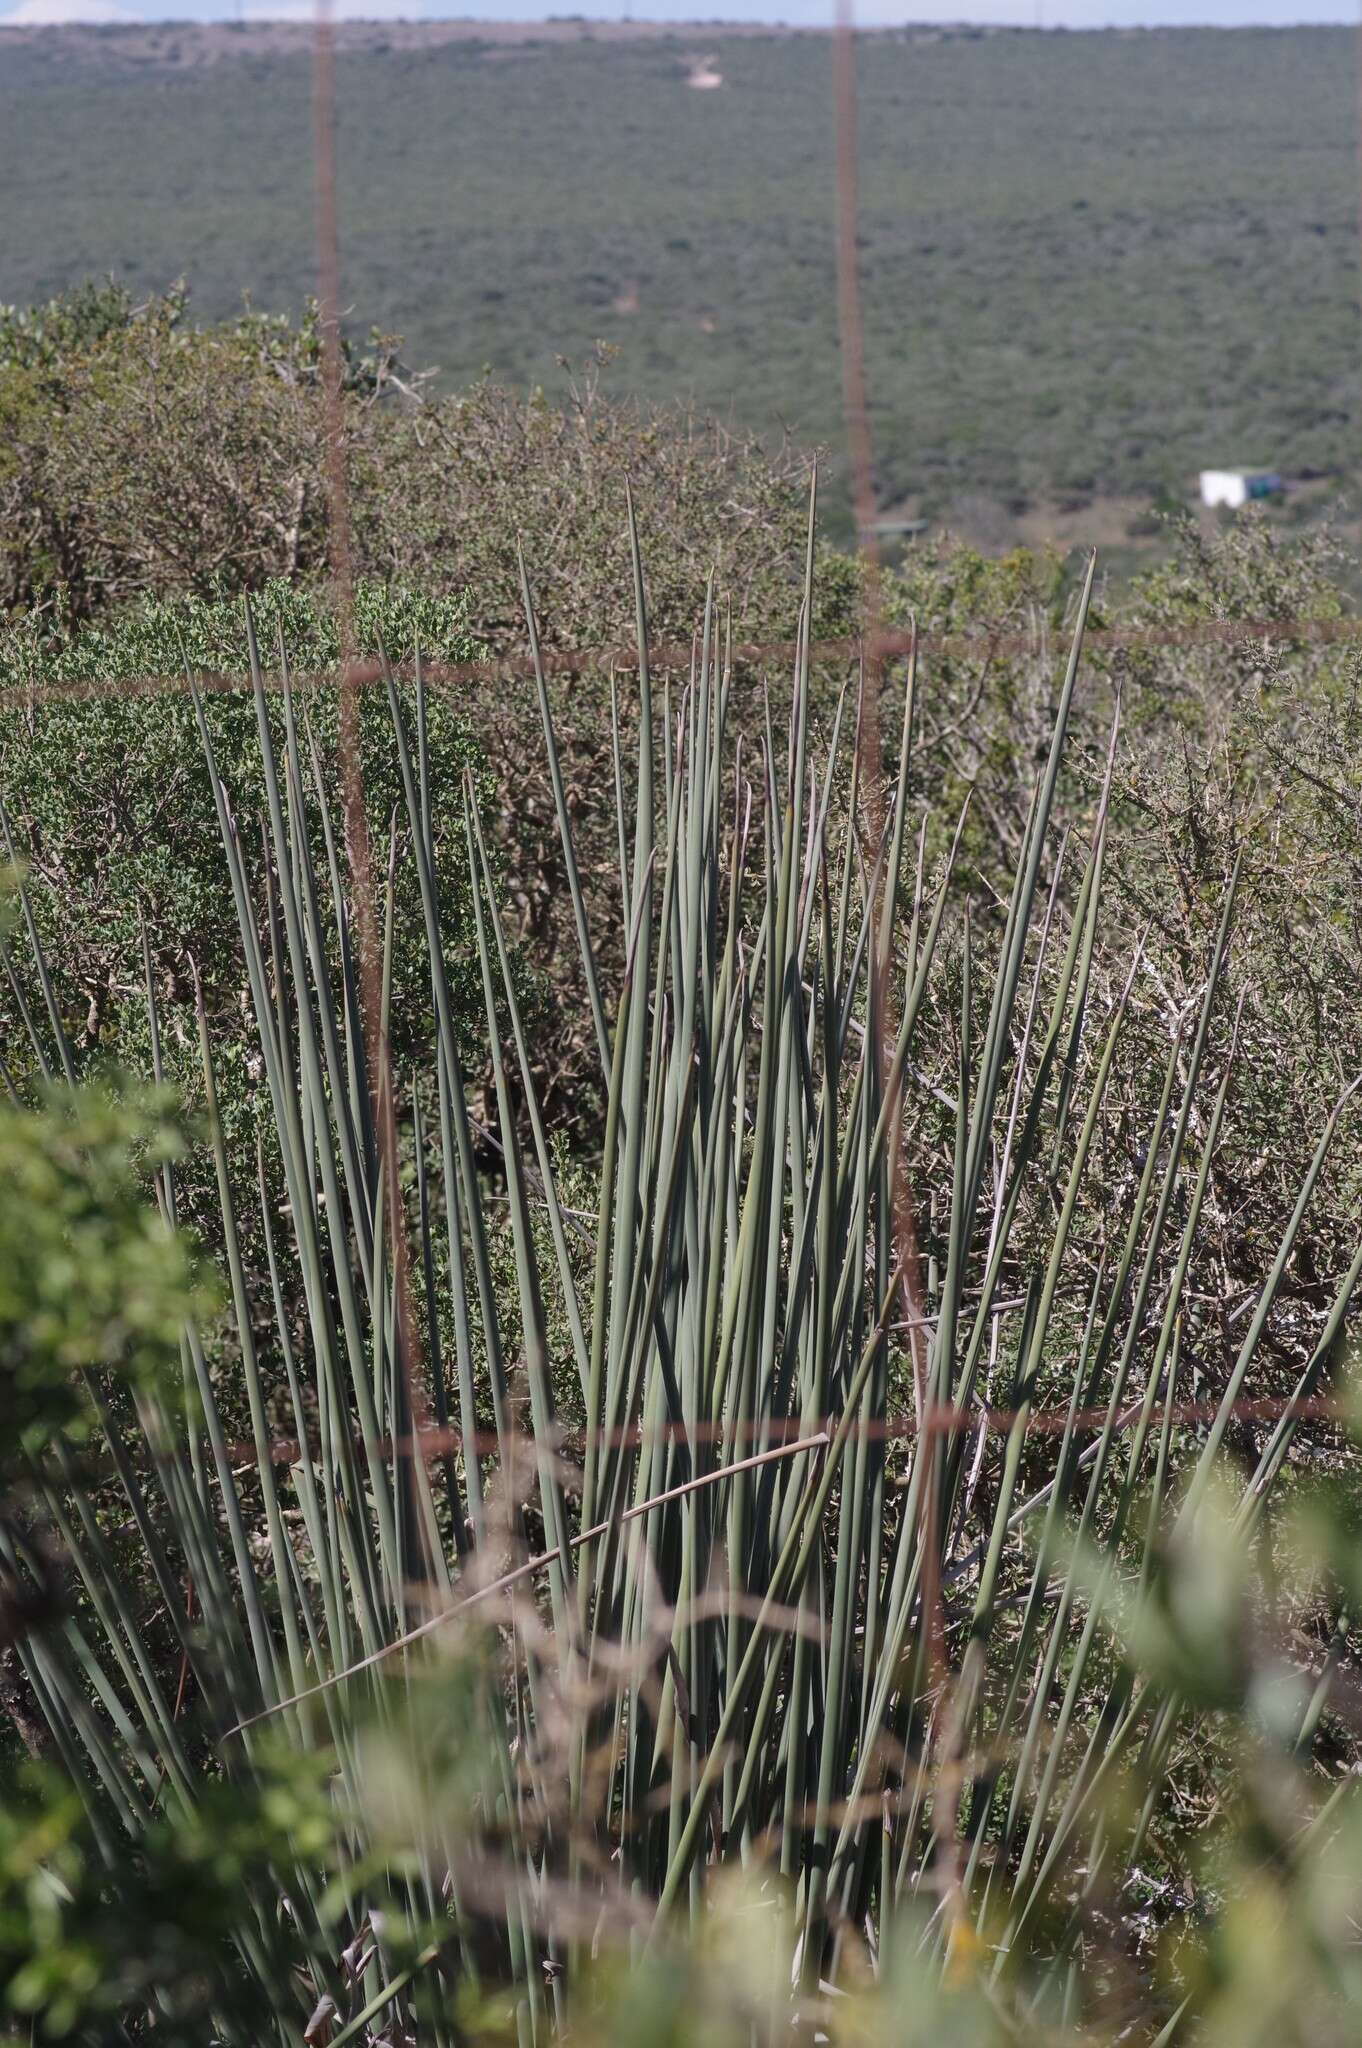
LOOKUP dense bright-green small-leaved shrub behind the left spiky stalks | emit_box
[0,582,499,1187]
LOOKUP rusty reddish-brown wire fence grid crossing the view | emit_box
[0,0,1362,1622]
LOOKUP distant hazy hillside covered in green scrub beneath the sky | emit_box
[0,23,1362,549]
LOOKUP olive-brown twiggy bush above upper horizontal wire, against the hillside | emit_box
[0,287,846,649]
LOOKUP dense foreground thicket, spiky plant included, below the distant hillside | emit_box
[0,295,1362,2048]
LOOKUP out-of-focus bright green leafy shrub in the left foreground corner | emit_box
[0,1090,332,2048]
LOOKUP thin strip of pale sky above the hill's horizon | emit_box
[0,0,1358,29]
